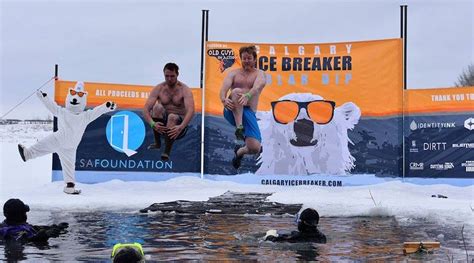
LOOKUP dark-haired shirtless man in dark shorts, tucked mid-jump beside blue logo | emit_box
[143,63,194,161]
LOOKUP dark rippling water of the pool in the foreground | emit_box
[0,211,474,262]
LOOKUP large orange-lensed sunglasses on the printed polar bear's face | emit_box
[271,100,336,124]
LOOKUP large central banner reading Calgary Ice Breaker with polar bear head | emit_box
[204,39,403,180]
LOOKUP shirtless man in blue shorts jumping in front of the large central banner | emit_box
[220,46,266,169]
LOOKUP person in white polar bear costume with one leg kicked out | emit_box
[18,81,116,194]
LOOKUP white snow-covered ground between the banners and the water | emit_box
[0,124,474,230]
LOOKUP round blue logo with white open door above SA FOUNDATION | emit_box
[105,111,145,157]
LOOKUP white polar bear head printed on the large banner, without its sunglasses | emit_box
[256,93,360,175]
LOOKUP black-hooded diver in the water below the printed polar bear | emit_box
[264,208,326,243]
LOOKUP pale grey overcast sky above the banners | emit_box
[0,0,474,119]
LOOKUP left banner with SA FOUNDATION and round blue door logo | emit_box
[53,81,201,182]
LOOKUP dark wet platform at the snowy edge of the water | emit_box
[140,191,302,215]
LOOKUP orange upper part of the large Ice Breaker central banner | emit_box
[205,39,403,116]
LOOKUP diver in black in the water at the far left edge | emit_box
[0,199,68,243]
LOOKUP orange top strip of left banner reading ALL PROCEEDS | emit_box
[54,80,202,112]
